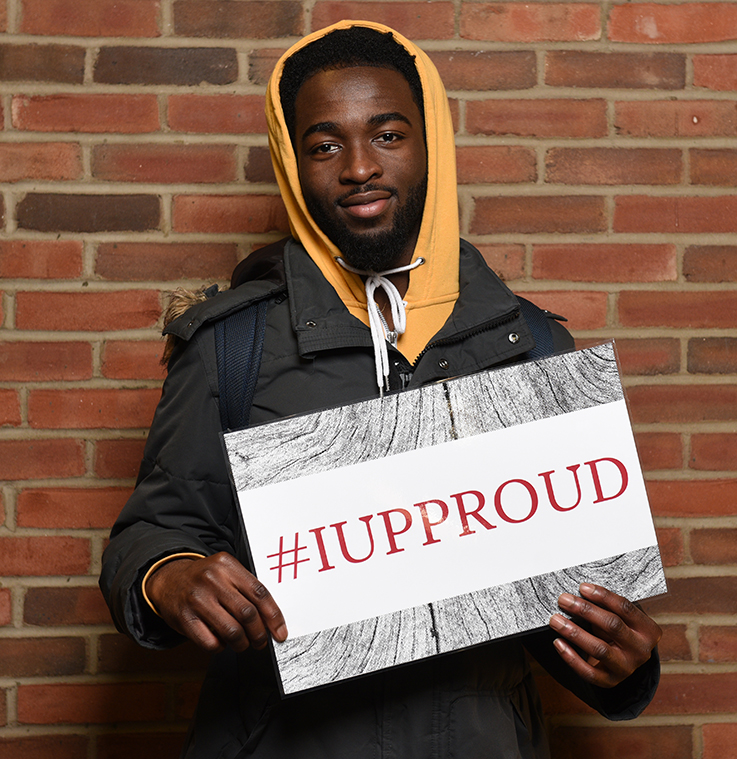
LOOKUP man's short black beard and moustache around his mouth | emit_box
[305,177,427,272]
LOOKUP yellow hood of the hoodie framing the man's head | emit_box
[266,20,459,361]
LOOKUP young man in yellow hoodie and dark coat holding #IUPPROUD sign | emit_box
[101,22,660,759]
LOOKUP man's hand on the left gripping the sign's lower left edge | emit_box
[146,553,287,652]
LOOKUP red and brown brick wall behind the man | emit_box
[0,0,737,759]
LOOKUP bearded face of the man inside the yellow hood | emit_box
[295,66,427,271]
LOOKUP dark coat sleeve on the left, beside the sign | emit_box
[100,327,244,648]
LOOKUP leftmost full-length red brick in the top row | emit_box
[20,0,161,37]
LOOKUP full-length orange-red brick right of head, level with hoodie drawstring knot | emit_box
[532,243,677,282]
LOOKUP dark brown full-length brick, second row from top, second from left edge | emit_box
[94,47,238,86]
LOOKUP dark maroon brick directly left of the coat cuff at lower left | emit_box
[23,585,111,627]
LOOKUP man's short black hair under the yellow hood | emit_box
[279,26,425,144]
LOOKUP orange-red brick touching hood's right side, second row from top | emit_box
[430,50,537,91]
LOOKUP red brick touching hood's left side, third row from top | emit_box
[168,94,266,134]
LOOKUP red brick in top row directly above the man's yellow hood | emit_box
[312,0,455,40]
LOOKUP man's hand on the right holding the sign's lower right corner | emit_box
[550,583,663,688]
